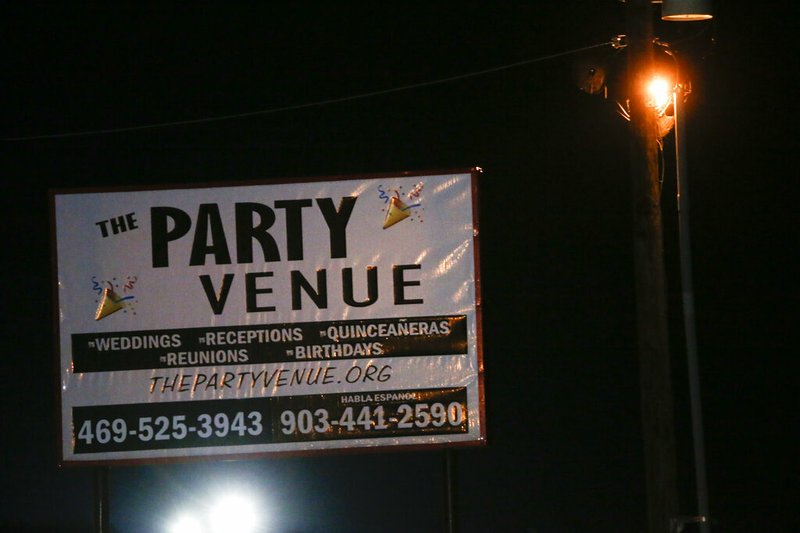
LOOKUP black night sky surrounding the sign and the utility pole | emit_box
[0,4,800,533]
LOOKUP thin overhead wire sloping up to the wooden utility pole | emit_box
[2,41,614,142]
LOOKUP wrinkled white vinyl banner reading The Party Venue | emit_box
[51,170,484,463]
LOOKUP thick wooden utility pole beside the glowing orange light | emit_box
[626,0,678,533]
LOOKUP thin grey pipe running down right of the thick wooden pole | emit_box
[673,81,711,533]
